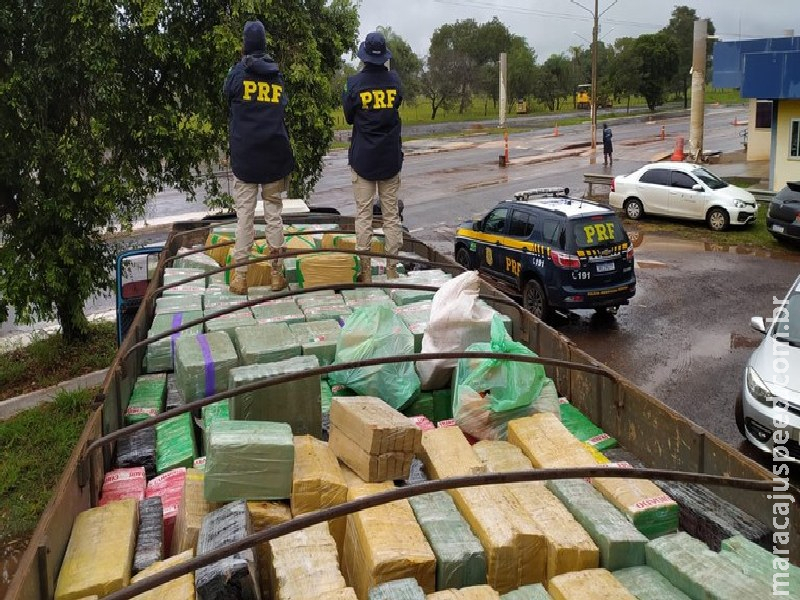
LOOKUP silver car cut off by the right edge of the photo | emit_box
[736,277,800,462]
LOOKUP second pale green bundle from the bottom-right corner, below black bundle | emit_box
[645,531,772,600]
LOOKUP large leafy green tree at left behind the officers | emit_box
[0,0,358,341]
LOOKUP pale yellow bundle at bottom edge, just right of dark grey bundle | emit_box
[269,523,346,600]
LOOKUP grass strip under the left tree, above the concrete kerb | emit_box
[0,322,117,400]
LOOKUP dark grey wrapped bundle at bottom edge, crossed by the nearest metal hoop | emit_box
[195,500,261,600]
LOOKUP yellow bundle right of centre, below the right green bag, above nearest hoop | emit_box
[508,413,597,469]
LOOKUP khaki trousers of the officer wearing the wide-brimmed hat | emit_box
[351,169,403,267]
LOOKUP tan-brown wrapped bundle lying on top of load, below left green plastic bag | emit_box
[331,396,422,454]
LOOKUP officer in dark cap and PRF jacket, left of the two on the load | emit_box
[224,21,295,295]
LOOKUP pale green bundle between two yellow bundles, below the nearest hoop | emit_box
[408,492,486,590]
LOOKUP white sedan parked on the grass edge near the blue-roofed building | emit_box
[608,162,758,231]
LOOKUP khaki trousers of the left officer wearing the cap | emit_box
[233,177,288,273]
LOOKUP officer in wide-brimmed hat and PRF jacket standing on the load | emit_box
[342,31,403,283]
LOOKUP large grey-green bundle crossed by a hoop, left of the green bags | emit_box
[230,356,322,438]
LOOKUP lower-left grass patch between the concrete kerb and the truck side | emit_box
[0,390,95,545]
